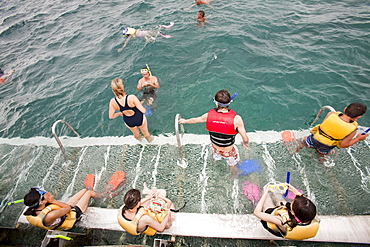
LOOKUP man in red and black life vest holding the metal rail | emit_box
[179,89,249,171]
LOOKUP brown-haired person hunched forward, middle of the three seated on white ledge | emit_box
[117,183,174,236]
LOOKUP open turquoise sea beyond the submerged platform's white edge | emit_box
[0,1,370,138]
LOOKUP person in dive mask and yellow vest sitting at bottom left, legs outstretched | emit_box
[24,187,97,230]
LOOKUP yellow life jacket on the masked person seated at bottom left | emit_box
[26,204,76,231]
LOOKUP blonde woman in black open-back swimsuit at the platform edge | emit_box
[109,78,154,142]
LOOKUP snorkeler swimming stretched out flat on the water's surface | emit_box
[118,22,175,52]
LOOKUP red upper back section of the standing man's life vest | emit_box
[206,109,238,135]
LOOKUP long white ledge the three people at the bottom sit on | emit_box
[18,207,370,244]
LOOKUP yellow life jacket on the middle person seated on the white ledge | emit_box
[117,205,168,236]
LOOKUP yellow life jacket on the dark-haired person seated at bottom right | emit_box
[267,206,320,240]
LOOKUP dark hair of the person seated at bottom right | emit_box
[290,196,317,227]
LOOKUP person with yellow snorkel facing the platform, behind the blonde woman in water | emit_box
[136,66,160,106]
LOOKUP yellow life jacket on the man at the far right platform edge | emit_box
[311,112,358,148]
